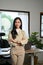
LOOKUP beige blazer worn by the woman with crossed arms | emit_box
[8,29,28,46]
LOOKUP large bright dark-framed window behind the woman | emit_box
[0,9,30,39]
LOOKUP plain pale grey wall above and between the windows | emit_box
[0,0,43,60]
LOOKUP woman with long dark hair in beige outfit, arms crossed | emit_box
[8,17,28,65]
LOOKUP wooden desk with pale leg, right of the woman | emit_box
[25,49,43,65]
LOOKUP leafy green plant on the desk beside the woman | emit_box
[28,32,43,49]
